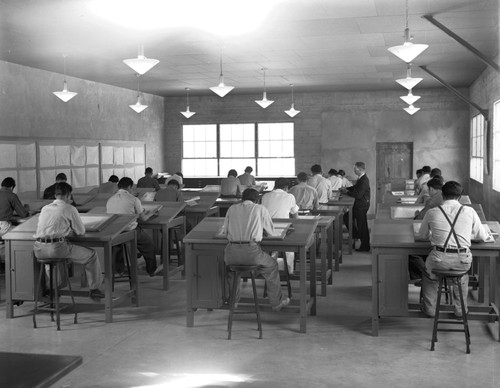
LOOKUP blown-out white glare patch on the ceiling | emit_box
[90,0,283,35]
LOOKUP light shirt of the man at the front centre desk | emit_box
[223,201,274,242]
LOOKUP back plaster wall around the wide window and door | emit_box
[164,88,469,213]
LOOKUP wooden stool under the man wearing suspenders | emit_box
[431,269,470,354]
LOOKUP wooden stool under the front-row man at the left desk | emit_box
[33,258,78,330]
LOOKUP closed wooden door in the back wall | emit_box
[376,143,413,203]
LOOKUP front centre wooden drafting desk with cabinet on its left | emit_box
[184,217,318,333]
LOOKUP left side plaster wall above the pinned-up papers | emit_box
[0,61,164,174]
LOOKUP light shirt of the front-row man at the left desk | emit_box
[34,199,85,238]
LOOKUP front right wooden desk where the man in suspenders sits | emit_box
[371,219,500,341]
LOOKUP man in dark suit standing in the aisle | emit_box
[341,162,370,252]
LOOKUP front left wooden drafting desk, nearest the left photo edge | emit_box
[3,215,139,323]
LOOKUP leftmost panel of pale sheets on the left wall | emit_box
[0,138,37,193]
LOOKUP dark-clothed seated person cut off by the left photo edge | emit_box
[0,177,28,237]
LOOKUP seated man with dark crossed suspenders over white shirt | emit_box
[416,181,491,317]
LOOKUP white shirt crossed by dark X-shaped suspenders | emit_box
[417,199,488,248]
